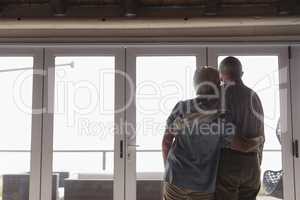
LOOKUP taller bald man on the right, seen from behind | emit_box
[216,57,265,200]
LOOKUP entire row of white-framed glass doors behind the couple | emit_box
[0,45,300,200]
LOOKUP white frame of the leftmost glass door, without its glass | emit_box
[0,46,44,200]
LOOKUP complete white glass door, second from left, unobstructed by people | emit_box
[41,46,125,200]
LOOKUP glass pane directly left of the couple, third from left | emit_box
[136,56,196,199]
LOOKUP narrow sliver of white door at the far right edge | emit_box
[290,46,300,199]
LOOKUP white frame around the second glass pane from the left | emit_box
[41,46,125,200]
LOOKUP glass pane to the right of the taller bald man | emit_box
[218,56,283,199]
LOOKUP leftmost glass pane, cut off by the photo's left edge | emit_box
[0,56,33,199]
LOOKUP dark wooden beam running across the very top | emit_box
[0,0,300,20]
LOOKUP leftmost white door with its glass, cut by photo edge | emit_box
[0,47,43,200]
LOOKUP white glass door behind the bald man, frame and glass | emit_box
[208,46,295,200]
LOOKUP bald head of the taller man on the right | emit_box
[219,56,243,82]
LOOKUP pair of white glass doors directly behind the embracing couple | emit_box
[125,46,295,200]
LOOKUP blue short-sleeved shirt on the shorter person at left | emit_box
[164,98,233,193]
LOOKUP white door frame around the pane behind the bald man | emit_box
[207,44,295,200]
